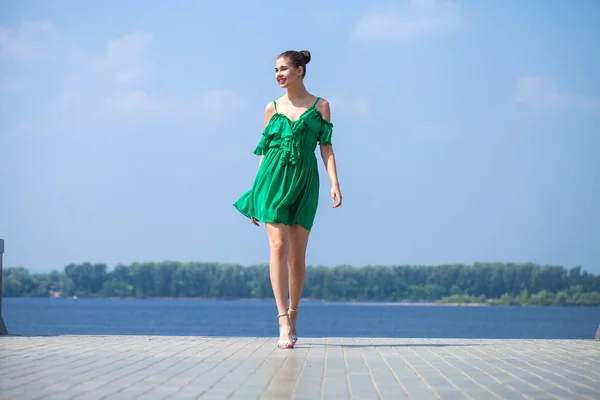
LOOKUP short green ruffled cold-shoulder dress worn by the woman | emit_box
[233,97,333,230]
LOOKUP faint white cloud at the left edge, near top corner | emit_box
[0,21,58,61]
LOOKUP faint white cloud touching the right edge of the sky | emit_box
[513,76,600,111]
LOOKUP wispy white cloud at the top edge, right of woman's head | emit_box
[354,0,461,40]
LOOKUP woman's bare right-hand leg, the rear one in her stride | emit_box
[288,224,310,335]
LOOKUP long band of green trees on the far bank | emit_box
[3,261,600,306]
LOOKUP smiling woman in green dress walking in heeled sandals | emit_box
[234,50,342,349]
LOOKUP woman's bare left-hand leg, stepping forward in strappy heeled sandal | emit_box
[265,223,292,346]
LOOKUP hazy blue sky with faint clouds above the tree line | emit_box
[0,0,600,273]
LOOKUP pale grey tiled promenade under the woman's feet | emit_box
[0,336,600,400]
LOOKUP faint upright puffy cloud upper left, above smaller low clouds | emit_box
[100,32,152,84]
